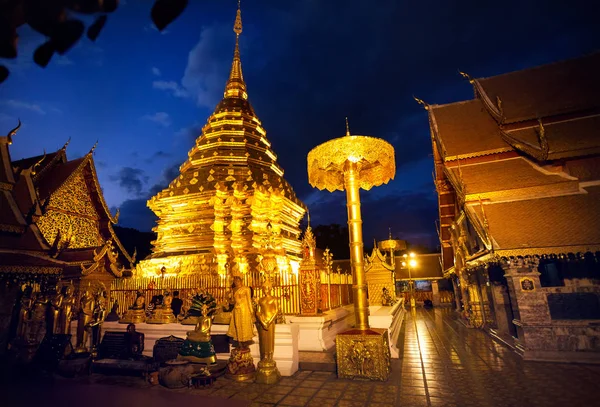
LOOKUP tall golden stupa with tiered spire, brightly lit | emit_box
[137,6,306,277]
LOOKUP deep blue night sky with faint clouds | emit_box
[0,0,600,247]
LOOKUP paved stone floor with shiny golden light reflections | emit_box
[0,309,600,407]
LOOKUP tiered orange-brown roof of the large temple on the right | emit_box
[426,53,600,272]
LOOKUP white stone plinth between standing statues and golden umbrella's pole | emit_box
[290,305,352,352]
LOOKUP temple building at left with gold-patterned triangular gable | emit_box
[0,123,135,350]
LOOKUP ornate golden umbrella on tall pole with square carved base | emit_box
[307,119,396,380]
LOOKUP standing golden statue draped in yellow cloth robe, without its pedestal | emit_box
[227,276,254,348]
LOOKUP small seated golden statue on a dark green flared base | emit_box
[177,304,217,364]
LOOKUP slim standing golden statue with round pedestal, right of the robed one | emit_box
[256,278,281,384]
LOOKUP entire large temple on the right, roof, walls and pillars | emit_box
[419,53,600,360]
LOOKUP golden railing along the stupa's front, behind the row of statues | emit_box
[110,273,300,315]
